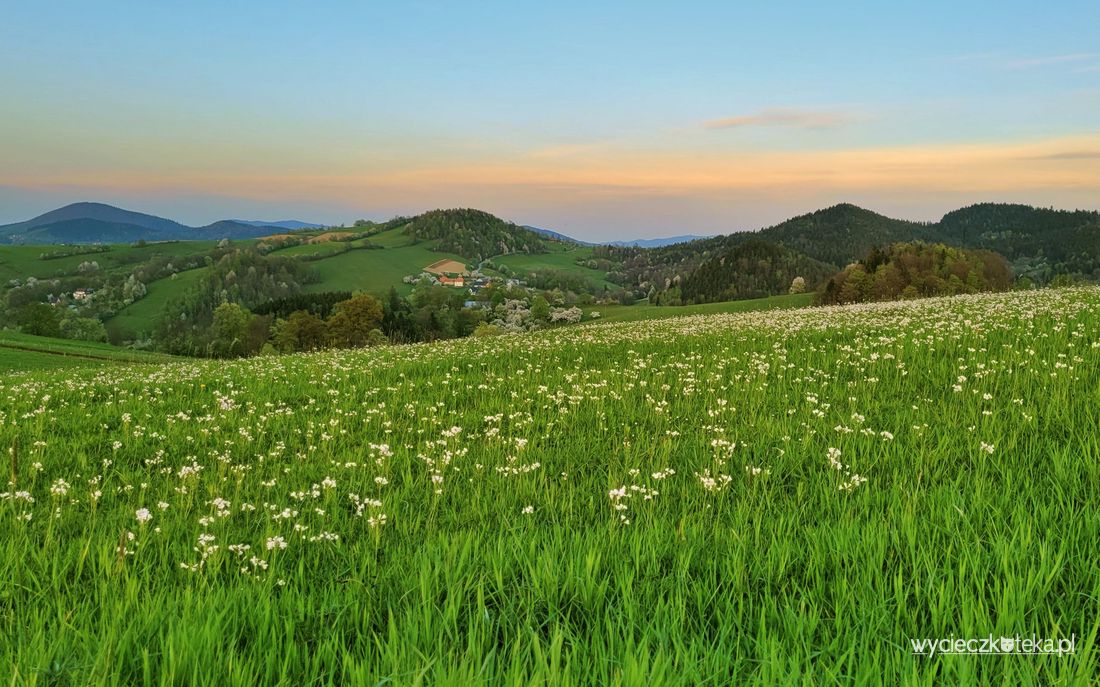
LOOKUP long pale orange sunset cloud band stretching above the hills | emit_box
[0,135,1100,207]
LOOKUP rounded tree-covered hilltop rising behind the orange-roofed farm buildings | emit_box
[389,209,550,259]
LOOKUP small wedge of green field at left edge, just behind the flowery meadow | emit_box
[0,331,176,373]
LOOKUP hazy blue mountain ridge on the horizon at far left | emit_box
[0,202,297,244]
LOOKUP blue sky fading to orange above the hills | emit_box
[0,0,1100,240]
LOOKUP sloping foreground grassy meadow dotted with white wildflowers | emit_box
[0,285,1100,686]
